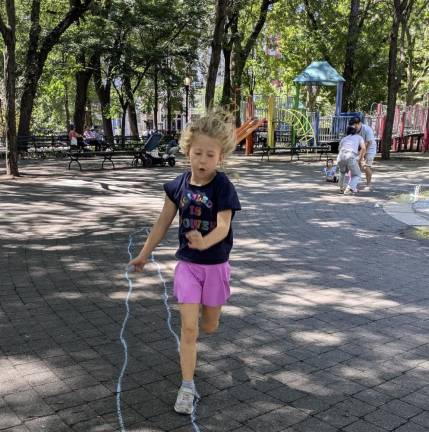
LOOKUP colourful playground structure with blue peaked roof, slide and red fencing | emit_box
[237,62,429,155]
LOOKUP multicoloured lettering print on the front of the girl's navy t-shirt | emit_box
[179,191,216,233]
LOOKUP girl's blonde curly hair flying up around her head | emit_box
[179,108,237,158]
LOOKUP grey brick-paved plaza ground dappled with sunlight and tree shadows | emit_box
[0,154,429,432]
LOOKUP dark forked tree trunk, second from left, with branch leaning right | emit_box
[18,0,92,136]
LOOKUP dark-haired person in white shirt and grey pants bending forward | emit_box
[337,126,366,195]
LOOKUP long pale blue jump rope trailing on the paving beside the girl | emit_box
[116,227,200,432]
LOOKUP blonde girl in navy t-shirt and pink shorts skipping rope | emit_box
[129,111,241,414]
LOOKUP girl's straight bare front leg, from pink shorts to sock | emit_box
[180,304,200,381]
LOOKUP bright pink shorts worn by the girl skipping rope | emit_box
[174,261,231,306]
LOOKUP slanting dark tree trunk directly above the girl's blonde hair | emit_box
[205,0,228,109]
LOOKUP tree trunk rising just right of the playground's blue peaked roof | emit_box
[341,0,360,112]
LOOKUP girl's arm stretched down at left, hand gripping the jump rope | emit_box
[128,196,177,271]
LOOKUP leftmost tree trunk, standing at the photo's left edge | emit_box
[0,0,19,177]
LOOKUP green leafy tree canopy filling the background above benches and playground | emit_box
[0,0,429,174]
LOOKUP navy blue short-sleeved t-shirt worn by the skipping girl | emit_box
[164,171,241,264]
